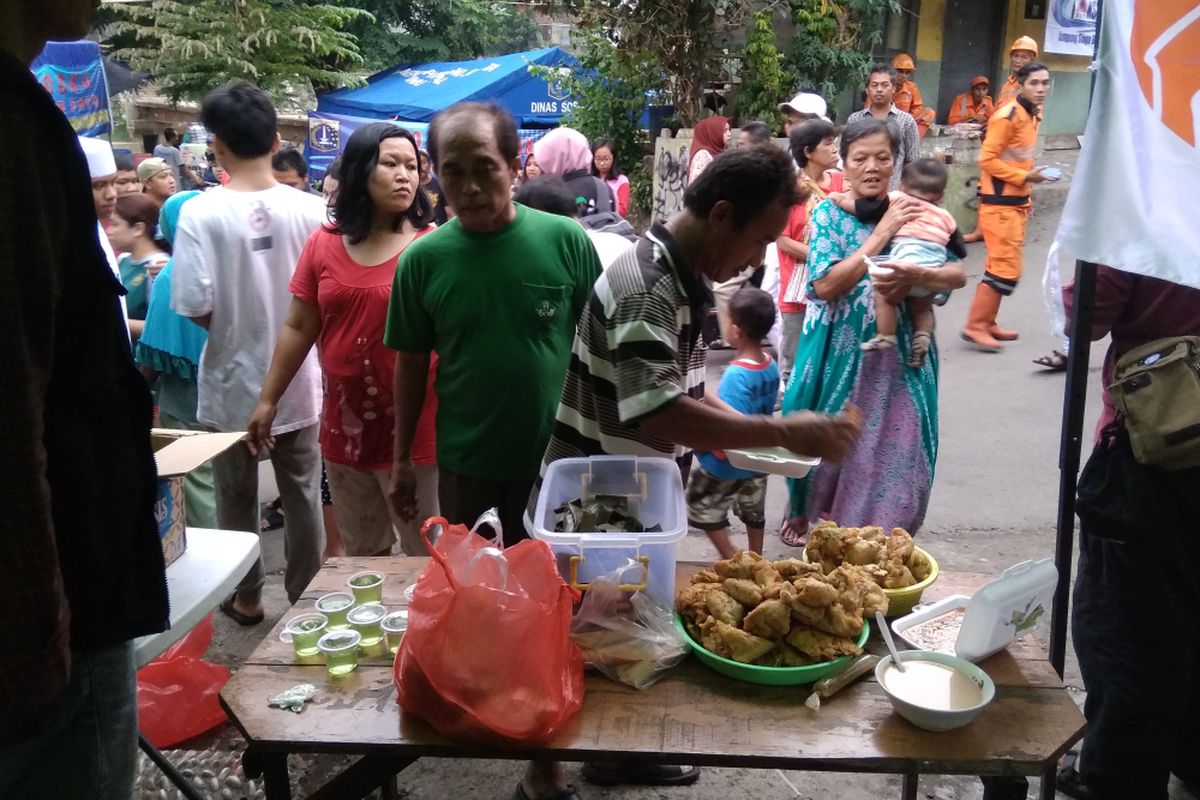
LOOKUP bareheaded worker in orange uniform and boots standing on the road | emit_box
[962,61,1050,353]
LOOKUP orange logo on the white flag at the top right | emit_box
[1129,0,1200,146]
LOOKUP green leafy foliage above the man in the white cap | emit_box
[784,0,901,100]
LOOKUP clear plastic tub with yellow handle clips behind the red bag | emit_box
[529,456,688,608]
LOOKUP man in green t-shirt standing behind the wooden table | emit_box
[384,103,600,545]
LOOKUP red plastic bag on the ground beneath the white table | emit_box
[138,614,229,750]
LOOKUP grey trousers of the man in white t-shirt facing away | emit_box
[212,425,325,604]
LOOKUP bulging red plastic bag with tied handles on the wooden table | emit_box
[395,517,583,745]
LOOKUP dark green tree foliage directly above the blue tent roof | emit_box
[349,0,540,71]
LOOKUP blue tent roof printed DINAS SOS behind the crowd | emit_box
[317,47,578,127]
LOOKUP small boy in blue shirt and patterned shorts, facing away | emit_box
[688,287,779,559]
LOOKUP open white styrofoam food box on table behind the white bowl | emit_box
[892,559,1058,662]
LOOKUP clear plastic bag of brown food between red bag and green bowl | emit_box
[571,560,689,688]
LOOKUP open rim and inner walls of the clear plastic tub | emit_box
[529,456,688,547]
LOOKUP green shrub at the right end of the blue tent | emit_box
[530,29,664,211]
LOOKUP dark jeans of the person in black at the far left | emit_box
[0,642,138,800]
